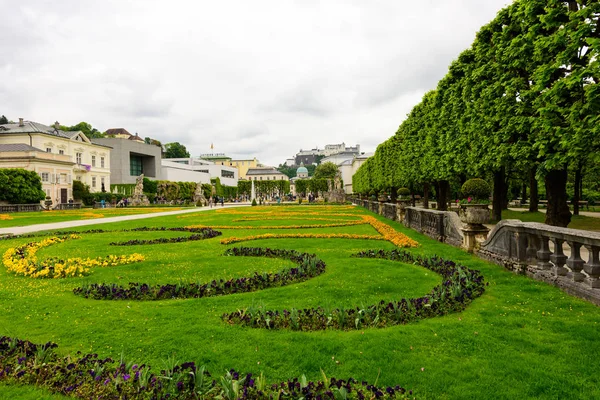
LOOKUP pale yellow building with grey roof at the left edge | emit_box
[0,118,111,203]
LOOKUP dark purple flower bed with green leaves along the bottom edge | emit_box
[0,336,412,400]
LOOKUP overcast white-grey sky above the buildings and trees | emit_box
[0,0,510,165]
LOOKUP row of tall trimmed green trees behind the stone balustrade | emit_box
[353,0,600,226]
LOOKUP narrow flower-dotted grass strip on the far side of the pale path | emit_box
[0,207,182,228]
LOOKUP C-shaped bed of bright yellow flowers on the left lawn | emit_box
[2,235,144,278]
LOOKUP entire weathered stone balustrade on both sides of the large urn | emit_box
[350,198,600,306]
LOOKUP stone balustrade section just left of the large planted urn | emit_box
[404,207,464,247]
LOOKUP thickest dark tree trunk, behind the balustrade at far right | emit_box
[545,168,571,228]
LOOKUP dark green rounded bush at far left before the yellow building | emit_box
[0,168,46,204]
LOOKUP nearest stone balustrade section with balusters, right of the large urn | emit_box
[477,220,600,305]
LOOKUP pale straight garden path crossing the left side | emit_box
[0,204,250,237]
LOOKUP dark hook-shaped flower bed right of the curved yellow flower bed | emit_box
[73,247,325,300]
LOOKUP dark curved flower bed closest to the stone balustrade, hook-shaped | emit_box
[222,250,485,331]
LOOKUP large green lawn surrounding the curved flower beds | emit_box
[0,206,600,399]
